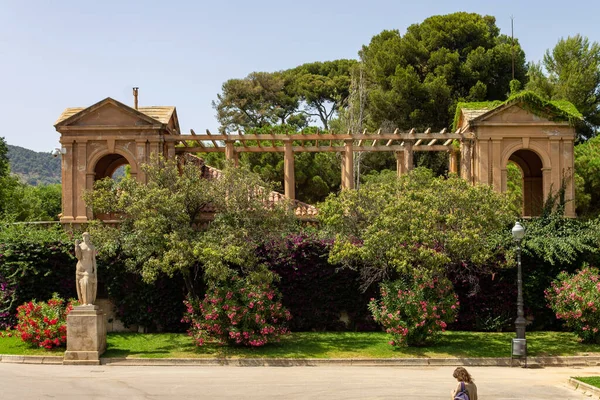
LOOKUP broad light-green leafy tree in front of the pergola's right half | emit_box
[319,168,516,285]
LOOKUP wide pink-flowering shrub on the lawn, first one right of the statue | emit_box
[183,277,291,346]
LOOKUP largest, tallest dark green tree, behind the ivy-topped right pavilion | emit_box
[360,12,526,129]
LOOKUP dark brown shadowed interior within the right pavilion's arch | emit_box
[508,149,544,217]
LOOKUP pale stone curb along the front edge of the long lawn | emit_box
[0,355,600,368]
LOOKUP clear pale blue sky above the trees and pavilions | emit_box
[0,0,600,151]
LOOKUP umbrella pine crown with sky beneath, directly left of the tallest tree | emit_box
[286,60,356,130]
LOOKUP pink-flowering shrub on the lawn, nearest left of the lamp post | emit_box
[369,276,459,346]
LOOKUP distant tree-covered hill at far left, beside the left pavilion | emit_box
[8,144,61,186]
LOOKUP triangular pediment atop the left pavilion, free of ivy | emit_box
[55,97,161,129]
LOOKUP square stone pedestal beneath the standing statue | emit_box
[63,305,106,365]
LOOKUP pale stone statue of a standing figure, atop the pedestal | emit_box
[75,232,98,305]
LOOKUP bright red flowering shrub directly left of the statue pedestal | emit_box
[17,294,73,349]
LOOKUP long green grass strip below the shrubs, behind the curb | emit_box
[0,332,600,358]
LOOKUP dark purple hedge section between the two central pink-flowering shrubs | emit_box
[257,233,377,332]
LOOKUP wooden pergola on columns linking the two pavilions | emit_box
[164,129,473,199]
